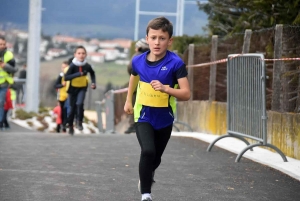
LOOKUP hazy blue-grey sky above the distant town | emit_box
[0,0,207,39]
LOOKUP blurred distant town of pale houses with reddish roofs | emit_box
[0,29,132,65]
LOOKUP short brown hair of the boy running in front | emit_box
[146,17,173,38]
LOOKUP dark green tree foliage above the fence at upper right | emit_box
[197,0,300,36]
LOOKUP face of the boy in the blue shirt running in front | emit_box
[146,28,173,59]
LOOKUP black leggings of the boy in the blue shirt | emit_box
[135,122,173,194]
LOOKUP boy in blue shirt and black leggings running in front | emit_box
[124,17,190,201]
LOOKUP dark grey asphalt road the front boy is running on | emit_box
[0,129,300,201]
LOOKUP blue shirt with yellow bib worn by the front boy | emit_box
[132,51,187,129]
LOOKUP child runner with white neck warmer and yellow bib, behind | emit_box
[65,46,96,135]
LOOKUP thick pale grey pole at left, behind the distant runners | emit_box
[25,0,42,112]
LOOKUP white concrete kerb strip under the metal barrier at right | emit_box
[172,132,300,181]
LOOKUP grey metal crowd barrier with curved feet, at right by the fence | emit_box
[207,54,287,162]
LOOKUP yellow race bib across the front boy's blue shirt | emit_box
[137,81,169,107]
